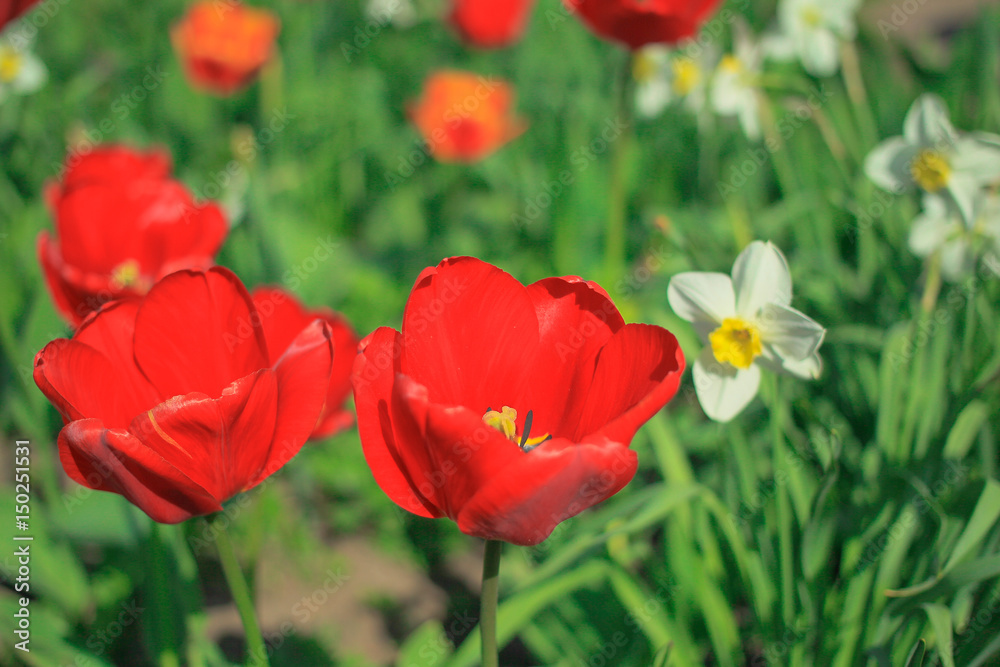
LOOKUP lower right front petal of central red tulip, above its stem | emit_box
[458,438,638,546]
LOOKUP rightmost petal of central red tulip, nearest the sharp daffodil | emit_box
[579,324,684,445]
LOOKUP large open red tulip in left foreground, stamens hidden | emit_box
[34,267,333,523]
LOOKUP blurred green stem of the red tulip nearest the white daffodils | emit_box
[604,56,633,285]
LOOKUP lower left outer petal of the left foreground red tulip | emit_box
[59,419,222,523]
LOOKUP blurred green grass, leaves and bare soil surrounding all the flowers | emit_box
[0,0,1000,667]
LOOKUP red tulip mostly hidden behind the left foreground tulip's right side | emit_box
[251,287,358,440]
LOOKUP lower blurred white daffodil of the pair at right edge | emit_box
[910,191,1000,282]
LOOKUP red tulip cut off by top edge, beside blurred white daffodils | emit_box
[563,0,720,50]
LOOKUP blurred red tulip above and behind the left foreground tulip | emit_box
[38,146,229,326]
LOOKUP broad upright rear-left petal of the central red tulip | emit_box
[400,257,538,413]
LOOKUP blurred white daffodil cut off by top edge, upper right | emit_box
[765,0,861,76]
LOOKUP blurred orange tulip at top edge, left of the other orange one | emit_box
[170,0,281,95]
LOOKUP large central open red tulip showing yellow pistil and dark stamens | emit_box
[353,257,684,545]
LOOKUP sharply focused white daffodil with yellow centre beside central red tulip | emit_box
[667,241,826,422]
